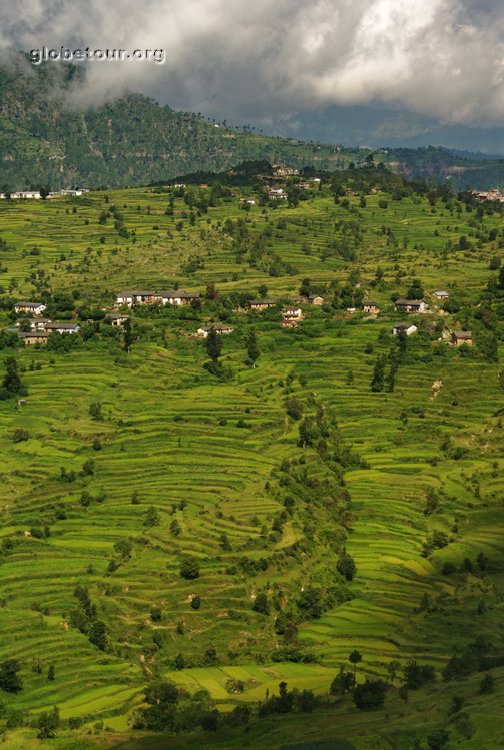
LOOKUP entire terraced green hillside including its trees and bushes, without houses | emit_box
[0,165,504,750]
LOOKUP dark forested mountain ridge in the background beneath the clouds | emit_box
[0,56,504,191]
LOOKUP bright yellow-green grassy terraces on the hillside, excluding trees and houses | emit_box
[0,179,504,750]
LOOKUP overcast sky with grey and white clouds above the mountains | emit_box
[0,0,504,124]
